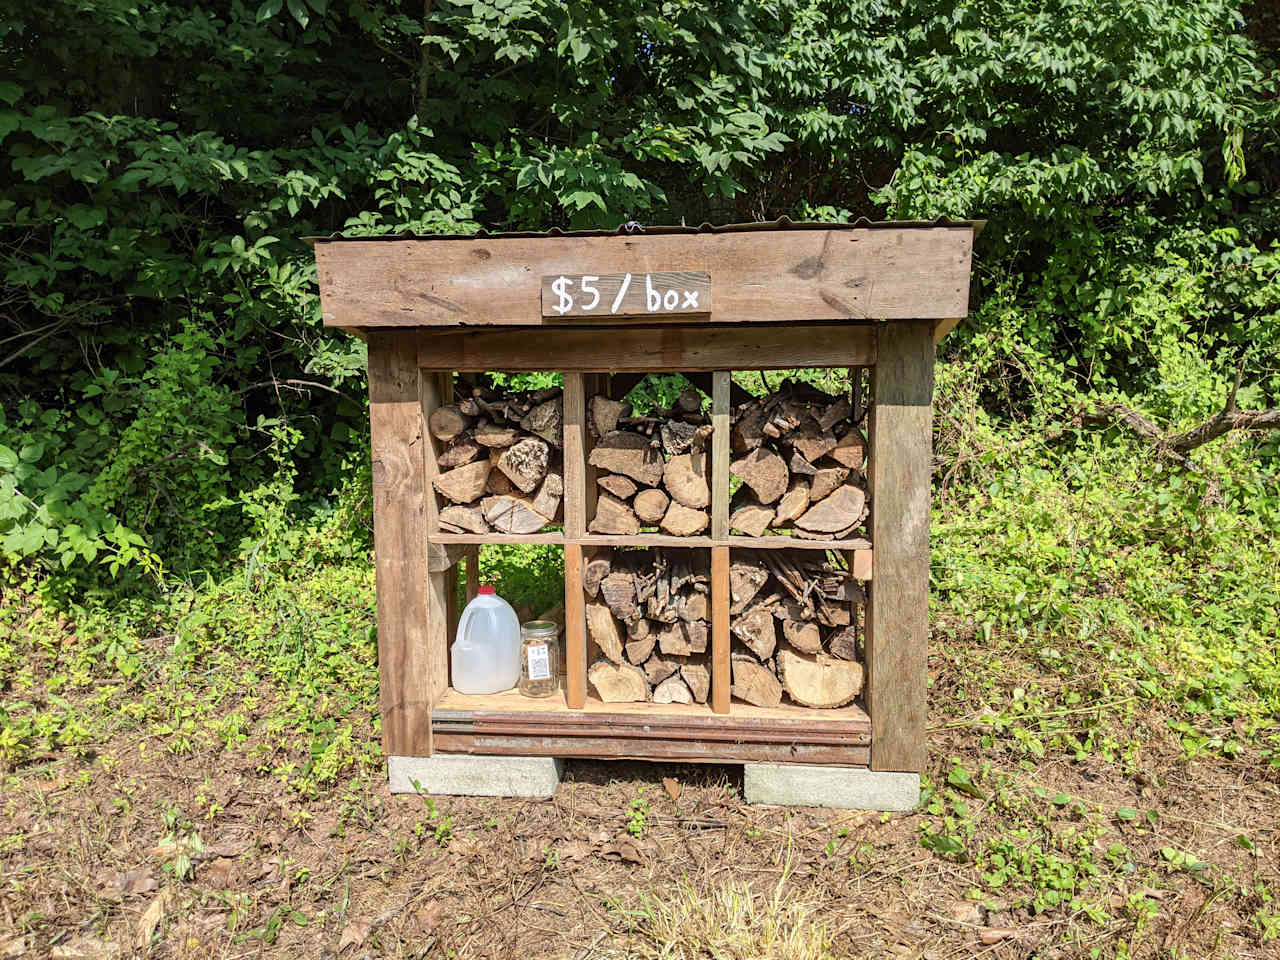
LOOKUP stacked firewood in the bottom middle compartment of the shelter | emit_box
[582,549,712,703]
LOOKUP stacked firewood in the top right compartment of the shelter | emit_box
[730,380,868,540]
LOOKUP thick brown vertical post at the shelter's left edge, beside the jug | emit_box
[369,332,439,756]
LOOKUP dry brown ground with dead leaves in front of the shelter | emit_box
[0,634,1280,960]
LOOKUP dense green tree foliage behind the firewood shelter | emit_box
[0,0,1280,586]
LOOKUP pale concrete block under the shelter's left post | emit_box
[387,754,564,799]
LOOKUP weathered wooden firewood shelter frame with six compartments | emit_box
[315,220,982,772]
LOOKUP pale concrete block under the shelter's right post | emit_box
[742,763,920,810]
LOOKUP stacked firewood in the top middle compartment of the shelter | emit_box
[588,388,712,536]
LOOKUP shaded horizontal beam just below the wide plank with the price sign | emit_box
[417,324,877,372]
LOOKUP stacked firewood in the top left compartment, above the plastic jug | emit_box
[428,387,564,534]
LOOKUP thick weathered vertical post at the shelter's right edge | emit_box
[865,320,933,772]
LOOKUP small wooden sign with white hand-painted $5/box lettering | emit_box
[543,271,712,319]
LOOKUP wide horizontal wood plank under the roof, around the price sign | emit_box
[315,225,973,327]
